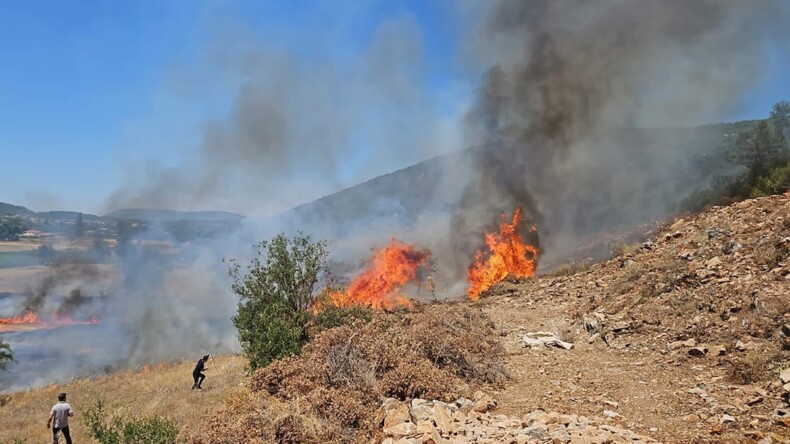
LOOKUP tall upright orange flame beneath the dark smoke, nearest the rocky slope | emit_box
[466,207,538,301]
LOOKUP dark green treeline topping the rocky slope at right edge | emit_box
[680,100,790,211]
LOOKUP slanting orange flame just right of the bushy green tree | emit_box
[328,239,431,309]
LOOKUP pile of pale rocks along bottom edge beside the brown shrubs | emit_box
[381,392,655,444]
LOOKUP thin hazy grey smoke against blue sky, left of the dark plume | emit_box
[105,16,464,216]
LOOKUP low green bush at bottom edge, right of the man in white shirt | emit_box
[84,400,178,444]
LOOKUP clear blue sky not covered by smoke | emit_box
[0,0,790,214]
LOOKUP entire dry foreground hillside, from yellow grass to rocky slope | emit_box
[0,194,790,443]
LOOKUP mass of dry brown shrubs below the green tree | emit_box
[206,304,506,443]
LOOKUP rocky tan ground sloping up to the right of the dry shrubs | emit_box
[382,195,790,443]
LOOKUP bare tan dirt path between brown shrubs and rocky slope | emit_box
[481,292,750,442]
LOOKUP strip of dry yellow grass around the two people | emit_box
[0,356,247,443]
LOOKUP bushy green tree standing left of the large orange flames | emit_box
[229,233,328,369]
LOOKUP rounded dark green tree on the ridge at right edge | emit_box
[729,120,788,178]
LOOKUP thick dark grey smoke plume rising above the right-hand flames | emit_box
[455,0,790,264]
